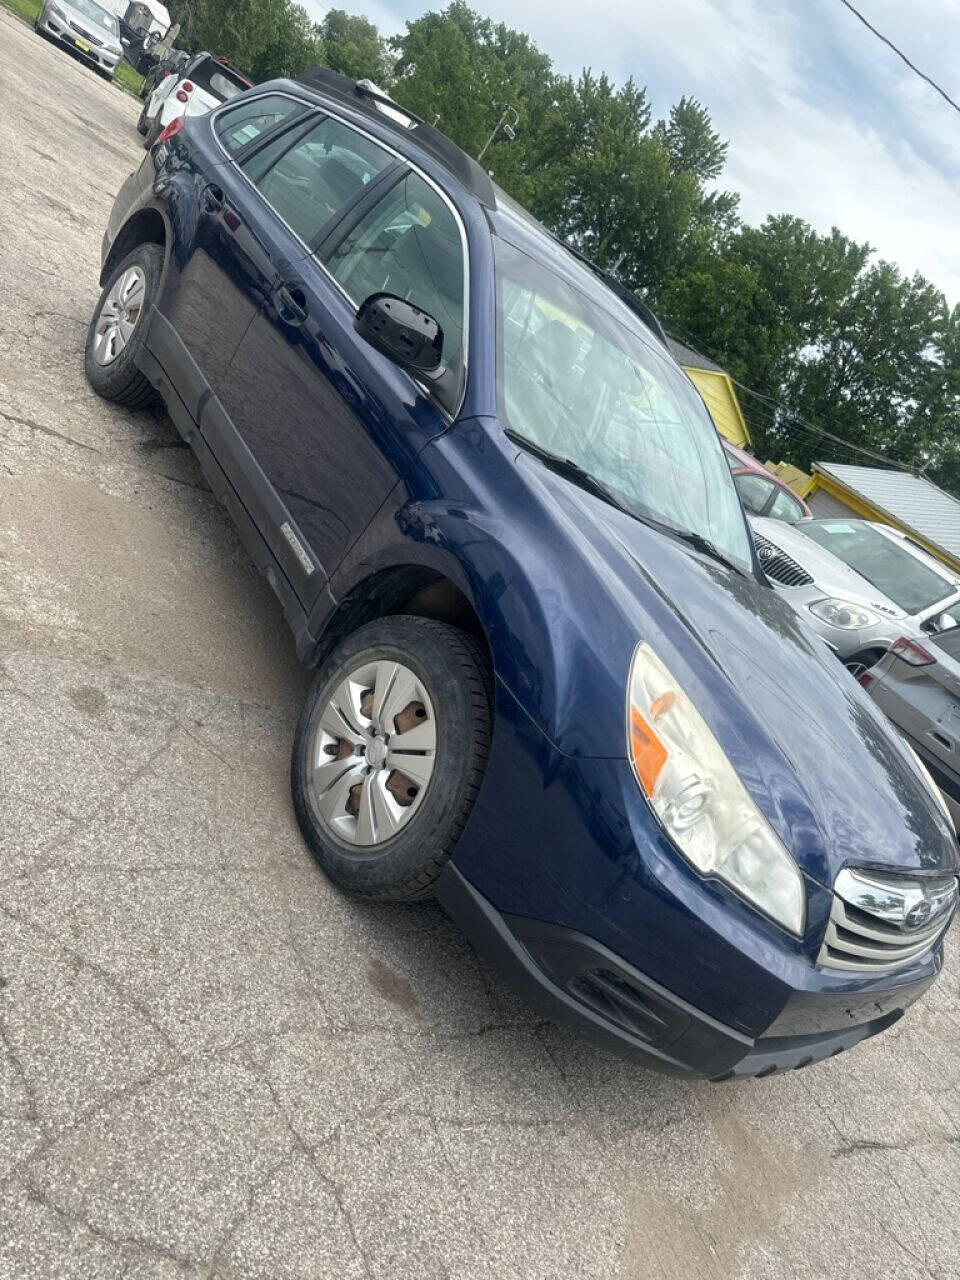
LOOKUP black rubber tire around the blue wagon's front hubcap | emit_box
[291,616,492,902]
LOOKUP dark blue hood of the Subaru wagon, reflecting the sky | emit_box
[529,472,957,886]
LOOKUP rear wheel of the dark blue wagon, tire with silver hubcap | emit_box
[83,244,164,408]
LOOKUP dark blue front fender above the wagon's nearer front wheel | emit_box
[330,419,636,756]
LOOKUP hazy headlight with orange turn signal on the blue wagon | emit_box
[627,644,805,936]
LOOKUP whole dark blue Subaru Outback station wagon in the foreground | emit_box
[86,64,957,1079]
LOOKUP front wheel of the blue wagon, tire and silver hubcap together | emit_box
[291,616,490,901]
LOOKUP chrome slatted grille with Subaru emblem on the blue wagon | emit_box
[817,870,957,973]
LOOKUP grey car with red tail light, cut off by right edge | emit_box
[860,624,960,822]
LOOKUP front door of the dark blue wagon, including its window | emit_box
[223,154,467,607]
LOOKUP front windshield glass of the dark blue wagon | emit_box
[494,237,751,567]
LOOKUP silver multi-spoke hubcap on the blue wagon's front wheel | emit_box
[307,659,436,847]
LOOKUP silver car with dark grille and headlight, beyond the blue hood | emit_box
[751,518,960,676]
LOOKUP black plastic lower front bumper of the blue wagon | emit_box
[436,863,938,1080]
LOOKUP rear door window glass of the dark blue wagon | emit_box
[243,118,394,244]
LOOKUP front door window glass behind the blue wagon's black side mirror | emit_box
[326,173,463,370]
